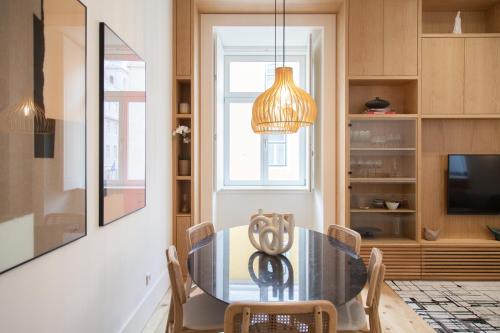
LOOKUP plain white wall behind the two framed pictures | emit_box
[0,0,172,333]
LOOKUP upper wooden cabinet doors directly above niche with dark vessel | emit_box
[349,0,418,76]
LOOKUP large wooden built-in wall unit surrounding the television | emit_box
[345,0,500,280]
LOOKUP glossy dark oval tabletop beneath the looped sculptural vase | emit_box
[188,226,366,306]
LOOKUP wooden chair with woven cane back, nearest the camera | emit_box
[224,301,337,333]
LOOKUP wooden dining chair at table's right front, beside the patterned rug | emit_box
[337,248,385,333]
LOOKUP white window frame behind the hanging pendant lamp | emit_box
[223,54,310,189]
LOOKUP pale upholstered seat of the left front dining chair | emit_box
[182,293,227,332]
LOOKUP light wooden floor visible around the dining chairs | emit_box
[143,284,434,333]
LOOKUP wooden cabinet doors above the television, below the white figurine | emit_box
[422,37,500,115]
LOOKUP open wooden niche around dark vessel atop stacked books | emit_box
[349,79,418,114]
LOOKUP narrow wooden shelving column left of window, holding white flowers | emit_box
[172,0,197,274]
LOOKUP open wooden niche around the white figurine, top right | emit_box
[422,0,500,34]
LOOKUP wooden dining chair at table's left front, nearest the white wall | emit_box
[166,245,227,333]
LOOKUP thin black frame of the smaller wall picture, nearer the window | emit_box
[99,22,147,227]
